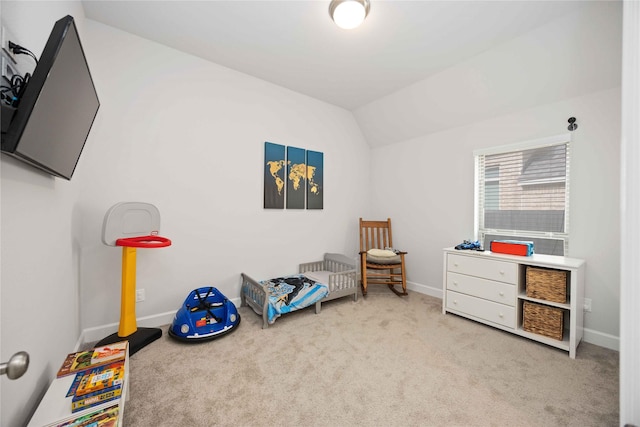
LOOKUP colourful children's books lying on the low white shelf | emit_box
[57,341,128,413]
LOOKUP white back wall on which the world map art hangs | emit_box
[76,20,369,333]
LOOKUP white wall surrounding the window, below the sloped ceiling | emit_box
[371,89,620,347]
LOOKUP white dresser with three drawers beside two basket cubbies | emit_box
[442,248,585,359]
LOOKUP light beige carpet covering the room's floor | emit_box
[124,287,618,427]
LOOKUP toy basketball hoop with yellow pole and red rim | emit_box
[96,202,171,355]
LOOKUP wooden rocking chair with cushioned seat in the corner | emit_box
[360,218,407,296]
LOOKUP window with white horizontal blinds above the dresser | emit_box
[474,135,570,255]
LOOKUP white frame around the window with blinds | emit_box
[473,133,571,256]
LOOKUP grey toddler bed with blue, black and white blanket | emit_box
[240,253,358,329]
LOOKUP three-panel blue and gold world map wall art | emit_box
[264,142,324,209]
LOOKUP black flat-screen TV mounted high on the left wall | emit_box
[2,16,100,180]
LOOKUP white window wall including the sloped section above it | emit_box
[364,3,621,348]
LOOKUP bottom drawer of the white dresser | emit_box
[447,291,516,329]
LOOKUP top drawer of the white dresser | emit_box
[447,254,518,284]
